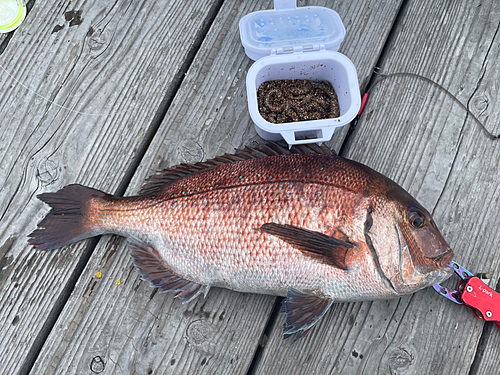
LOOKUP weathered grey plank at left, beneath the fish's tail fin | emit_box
[0,0,219,374]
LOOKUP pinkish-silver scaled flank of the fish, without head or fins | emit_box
[97,183,388,300]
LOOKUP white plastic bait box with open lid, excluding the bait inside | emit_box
[239,0,361,146]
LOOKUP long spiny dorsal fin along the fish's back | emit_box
[139,143,335,195]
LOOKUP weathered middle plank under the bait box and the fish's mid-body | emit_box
[28,0,399,374]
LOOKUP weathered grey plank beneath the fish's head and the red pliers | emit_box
[256,1,500,375]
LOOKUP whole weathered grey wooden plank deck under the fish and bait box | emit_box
[0,0,500,375]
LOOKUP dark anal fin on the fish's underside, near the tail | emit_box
[128,242,210,303]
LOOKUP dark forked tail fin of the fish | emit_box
[28,185,113,250]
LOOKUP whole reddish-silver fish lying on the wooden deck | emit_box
[28,143,453,337]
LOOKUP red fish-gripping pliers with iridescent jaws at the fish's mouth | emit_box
[433,261,500,330]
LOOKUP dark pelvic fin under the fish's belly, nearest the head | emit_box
[281,288,333,339]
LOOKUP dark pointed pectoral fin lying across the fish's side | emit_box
[257,223,355,270]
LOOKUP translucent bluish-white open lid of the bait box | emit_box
[239,0,345,60]
